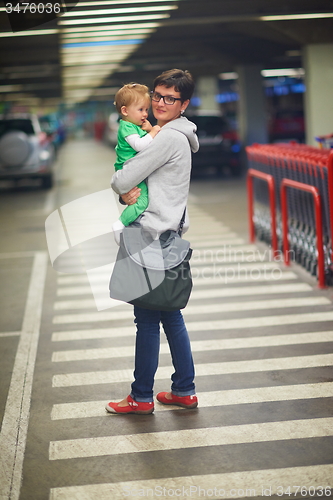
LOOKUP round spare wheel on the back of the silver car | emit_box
[0,131,31,167]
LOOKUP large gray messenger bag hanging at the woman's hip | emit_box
[109,216,192,311]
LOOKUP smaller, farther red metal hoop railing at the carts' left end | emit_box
[247,168,278,256]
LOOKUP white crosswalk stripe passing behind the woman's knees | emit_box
[52,331,333,363]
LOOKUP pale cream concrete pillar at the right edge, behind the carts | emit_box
[303,43,333,146]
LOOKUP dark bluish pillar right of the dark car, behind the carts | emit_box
[237,65,268,146]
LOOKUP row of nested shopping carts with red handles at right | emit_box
[246,142,333,285]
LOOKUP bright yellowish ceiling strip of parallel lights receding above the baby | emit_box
[58,0,178,104]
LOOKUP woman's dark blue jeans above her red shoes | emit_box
[131,306,195,402]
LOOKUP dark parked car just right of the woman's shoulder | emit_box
[186,111,241,176]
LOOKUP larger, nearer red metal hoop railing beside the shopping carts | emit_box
[281,179,325,288]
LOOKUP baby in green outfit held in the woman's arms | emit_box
[112,83,161,245]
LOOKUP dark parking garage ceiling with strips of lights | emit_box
[0,0,333,105]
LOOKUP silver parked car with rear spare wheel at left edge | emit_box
[0,114,54,189]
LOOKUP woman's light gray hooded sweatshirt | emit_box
[111,117,199,234]
